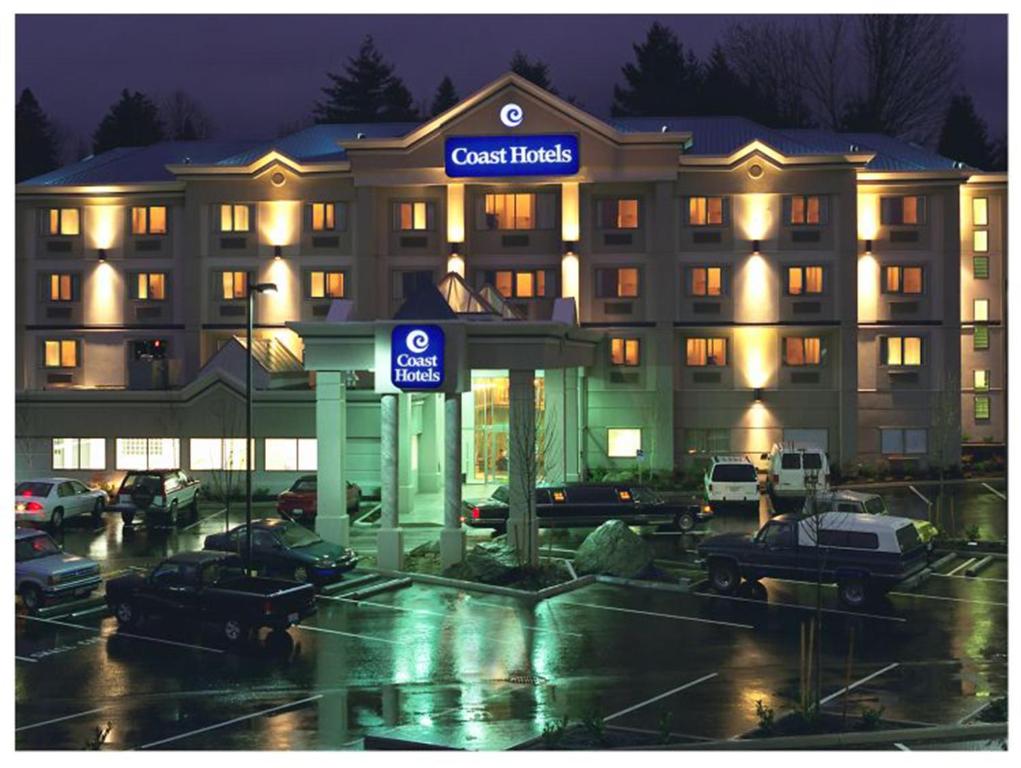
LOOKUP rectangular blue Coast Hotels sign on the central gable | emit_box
[443,134,579,179]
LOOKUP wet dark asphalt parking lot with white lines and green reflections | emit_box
[15,491,1008,750]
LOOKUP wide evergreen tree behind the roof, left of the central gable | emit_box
[313,35,419,123]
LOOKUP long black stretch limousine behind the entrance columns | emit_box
[461,483,713,531]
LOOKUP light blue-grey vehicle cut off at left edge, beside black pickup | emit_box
[14,527,102,612]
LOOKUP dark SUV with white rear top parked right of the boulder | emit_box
[698,512,928,608]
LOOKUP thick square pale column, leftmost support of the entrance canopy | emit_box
[315,371,350,546]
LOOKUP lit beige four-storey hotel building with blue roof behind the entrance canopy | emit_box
[15,75,1007,535]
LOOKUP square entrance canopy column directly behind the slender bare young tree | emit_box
[507,369,539,564]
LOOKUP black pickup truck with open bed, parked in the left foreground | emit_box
[106,550,315,643]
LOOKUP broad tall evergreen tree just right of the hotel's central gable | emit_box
[611,21,699,116]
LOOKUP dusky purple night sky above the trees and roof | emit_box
[15,15,1007,150]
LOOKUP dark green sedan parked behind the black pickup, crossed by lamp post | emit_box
[203,518,358,586]
